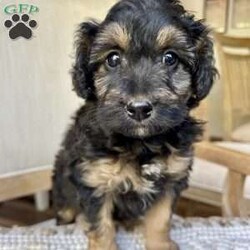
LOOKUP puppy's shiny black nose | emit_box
[126,101,153,121]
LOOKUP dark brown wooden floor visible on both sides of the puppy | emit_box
[0,197,221,227]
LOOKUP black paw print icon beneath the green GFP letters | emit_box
[4,14,37,39]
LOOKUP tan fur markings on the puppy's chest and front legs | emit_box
[79,147,188,250]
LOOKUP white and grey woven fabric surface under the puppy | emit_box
[0,217,250,250]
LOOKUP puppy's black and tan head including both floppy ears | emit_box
[73,0,216,137]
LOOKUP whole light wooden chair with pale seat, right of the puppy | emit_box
[184,33,250,216]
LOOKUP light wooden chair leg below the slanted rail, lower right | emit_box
[222,170,247,217]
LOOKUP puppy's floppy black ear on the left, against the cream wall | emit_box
[72,22,99,99]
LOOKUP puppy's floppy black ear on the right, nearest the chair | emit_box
[190,21,217,106]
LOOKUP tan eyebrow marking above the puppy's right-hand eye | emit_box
[156,26,186,49]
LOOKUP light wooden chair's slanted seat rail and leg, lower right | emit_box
[196,142,250,216]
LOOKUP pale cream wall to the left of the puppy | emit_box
[0,0,115,174]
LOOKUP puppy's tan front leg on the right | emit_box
[143,195,179,250]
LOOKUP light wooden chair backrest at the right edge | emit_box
[214,33,250,142]
